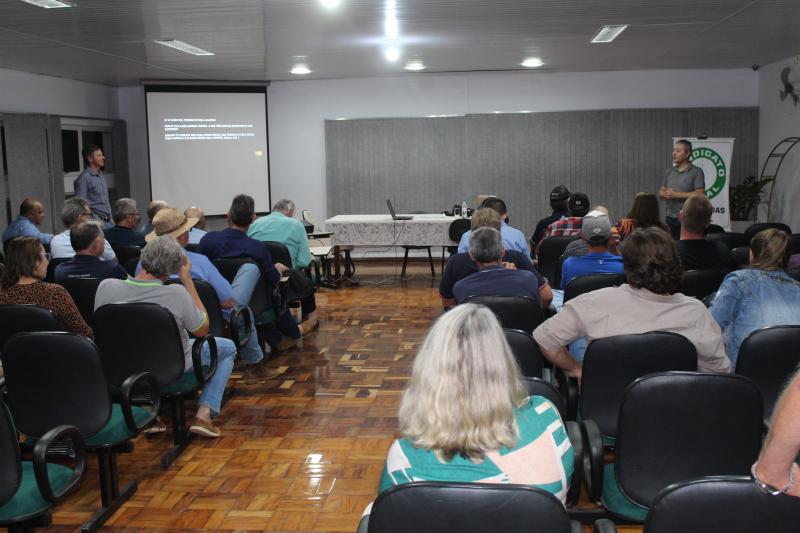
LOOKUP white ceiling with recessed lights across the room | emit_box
[0,0,800,85]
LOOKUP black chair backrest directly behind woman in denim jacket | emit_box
[736,326,800,417]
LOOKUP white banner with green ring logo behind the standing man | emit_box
[673,137,734,230]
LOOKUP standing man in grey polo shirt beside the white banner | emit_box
[658,139,706,239]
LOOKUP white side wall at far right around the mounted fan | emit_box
[758,56,800,232]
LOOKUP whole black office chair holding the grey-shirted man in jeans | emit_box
[94,303,217,468]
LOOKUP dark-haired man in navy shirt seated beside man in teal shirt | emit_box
[200,194,311,351]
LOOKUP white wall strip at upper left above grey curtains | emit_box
[0,69,116,118]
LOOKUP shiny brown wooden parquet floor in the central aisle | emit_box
[48,263,640,532]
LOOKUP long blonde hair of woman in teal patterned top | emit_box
[399,304,526,461]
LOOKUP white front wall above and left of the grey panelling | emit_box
[268,69,759,221]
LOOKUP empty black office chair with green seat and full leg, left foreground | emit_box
[2,332,159,531]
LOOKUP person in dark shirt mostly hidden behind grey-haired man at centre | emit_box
[439,207,553,308]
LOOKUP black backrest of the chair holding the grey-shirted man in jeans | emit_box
[94,303,184,387]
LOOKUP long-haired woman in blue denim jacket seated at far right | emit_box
[708,227,800,365]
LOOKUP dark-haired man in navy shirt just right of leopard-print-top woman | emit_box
[55,220,128,283]
